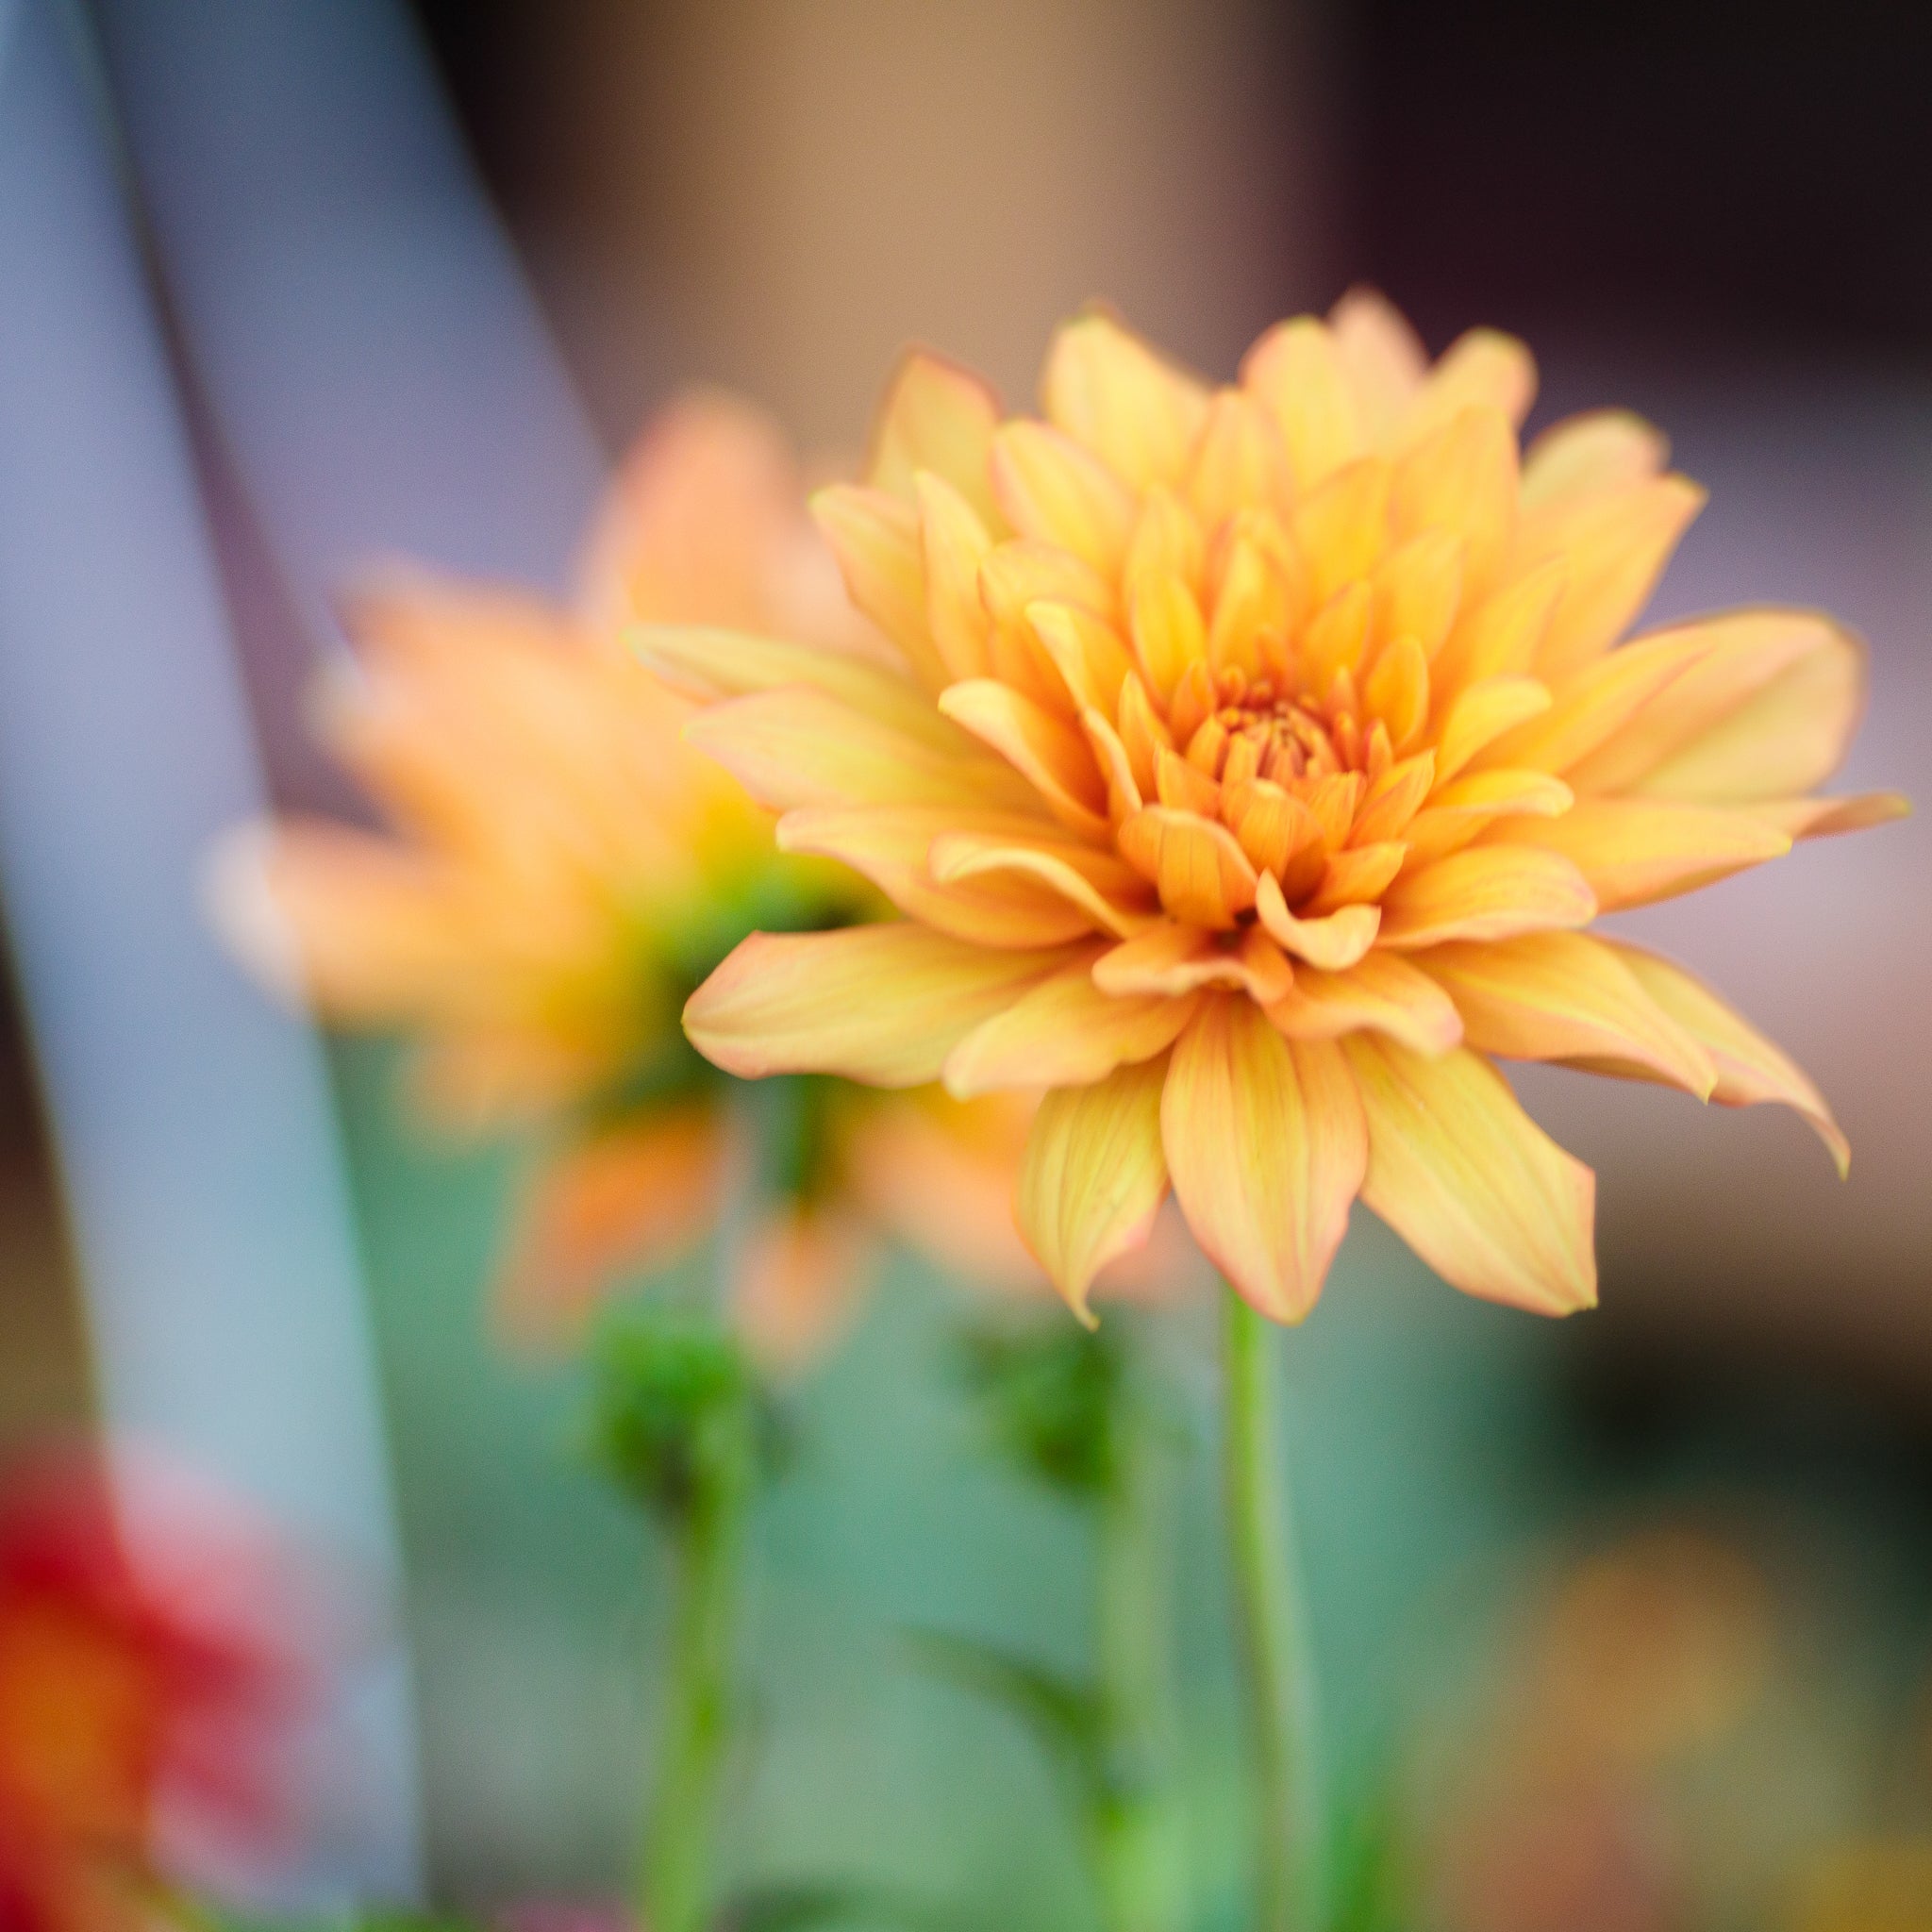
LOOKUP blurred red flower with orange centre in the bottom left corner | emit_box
[0,1460,311,1932]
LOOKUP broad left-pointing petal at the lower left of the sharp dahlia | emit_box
[684,924,1066,1088]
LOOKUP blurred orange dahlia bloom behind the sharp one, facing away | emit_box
[212,396,1030,1358]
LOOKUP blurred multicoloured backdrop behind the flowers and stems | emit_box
[0,0,1932,1932]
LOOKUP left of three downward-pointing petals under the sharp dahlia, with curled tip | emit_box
[1014,1058,1167,1327]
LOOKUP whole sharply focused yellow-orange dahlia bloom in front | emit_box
[660,293,1903,1322]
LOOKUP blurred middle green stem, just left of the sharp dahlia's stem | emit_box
[1093,1372,1184,1932]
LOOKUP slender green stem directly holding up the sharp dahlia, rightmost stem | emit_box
[1221,1292,1325,1932]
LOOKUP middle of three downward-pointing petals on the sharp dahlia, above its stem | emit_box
[1161,993,1368,1322]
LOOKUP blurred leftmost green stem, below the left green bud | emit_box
[640,1405,754,1932]
